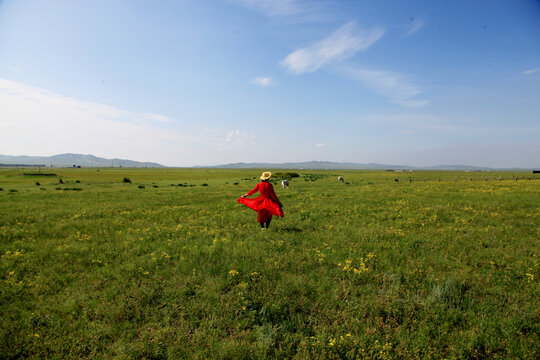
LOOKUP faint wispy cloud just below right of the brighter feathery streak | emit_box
[345,68,429,108]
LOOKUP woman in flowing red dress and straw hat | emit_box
[236,171,284,230]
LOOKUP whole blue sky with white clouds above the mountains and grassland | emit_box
[0,0,540,168]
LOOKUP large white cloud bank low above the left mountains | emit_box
[0,79,207,164]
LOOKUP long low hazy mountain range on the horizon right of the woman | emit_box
[209,161,517,171]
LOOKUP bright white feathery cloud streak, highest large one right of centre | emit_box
[280,22,384,74]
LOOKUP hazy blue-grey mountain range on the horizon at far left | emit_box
[0,154,165,168]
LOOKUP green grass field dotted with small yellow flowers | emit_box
[0,169,540,359]
